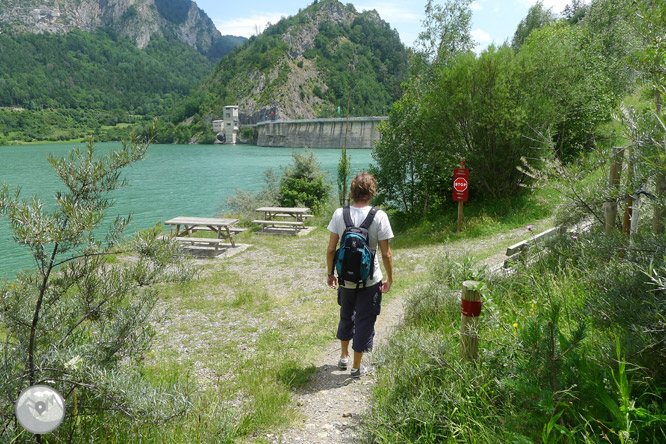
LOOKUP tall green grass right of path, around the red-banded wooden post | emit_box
[365,227,666,443]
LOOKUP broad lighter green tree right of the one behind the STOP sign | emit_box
[517,0,634,162]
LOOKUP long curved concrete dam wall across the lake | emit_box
[256,116,388,148]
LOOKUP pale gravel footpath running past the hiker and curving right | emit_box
[265,228,529,444]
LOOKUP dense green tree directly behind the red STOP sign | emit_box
[424,46,540,198]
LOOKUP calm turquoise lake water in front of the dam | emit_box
[0,143,373,279]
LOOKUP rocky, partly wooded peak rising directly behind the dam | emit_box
[189,0,408,122]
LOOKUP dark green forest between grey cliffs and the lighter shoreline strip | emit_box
[0,31,212,114]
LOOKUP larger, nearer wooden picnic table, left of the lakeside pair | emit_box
[164,216,245,251]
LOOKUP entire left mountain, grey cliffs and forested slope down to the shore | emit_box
[0,0,246,144]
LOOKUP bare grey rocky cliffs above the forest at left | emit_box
[0,0,238,60]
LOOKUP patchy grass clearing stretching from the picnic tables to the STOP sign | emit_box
[83,193,550,443]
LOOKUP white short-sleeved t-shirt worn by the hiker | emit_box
[328,206,393,288]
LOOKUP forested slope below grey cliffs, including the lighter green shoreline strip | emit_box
[0,31,219,144]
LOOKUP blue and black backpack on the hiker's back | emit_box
[331,207,377,289]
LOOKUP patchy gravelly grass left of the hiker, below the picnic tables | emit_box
[138,229,337,442]
